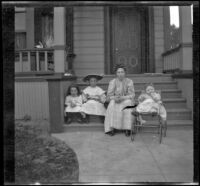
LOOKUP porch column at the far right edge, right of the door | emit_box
[179,6,192,71]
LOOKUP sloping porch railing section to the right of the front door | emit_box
[162,45,181,73]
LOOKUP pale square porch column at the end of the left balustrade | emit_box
[53,7,66,73]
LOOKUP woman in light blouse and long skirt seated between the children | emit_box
[104,64,135,136]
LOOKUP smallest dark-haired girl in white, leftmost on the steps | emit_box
[65,85,83,124]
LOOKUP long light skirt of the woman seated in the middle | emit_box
[104,100,134,133]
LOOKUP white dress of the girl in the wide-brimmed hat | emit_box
[81,86,106,116]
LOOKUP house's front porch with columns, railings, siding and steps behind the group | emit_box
[15,6,193,132]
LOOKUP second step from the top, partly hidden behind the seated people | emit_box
[77,81,178,90]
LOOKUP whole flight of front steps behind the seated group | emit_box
[64,74,193,131]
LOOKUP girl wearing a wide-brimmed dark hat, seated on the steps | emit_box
[81,75,106,121]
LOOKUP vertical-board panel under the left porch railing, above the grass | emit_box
[15,81,49,119]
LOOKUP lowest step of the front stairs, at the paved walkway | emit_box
[64,120,193,132]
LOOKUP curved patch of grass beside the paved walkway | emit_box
[15,121,79,184]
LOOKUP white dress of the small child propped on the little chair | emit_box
[136,92,167,120]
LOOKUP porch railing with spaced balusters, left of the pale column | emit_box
[15,48,54,72]
